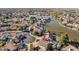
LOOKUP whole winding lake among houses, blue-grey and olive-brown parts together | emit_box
[30,15,79,41]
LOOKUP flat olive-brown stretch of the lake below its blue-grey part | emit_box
[46,24,79,41]
